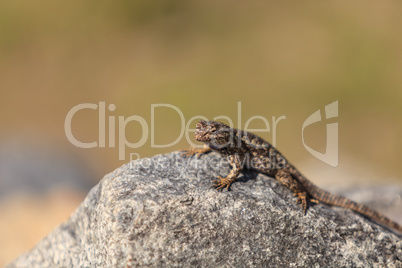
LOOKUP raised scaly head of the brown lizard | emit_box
[194,120,233,147]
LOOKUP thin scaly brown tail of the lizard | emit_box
[309,183,402,233]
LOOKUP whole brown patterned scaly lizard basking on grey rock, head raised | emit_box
[182,120,402,233]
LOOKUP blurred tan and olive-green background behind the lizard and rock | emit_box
[0,0,402,266]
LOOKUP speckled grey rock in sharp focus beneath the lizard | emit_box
[9,152,402,267]
